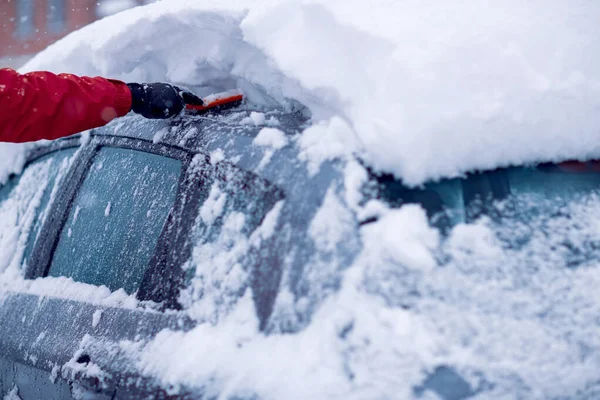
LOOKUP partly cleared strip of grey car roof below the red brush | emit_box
[85,107,341,206]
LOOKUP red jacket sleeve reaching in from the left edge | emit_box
[0,69,131,143]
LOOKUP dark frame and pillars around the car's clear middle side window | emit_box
[25,133,285,310]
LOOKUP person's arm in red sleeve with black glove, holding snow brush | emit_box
[0,69,203,143]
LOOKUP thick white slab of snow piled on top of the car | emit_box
[24,0,600,184]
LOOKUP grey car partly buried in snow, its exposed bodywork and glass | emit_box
[0,104,600,400]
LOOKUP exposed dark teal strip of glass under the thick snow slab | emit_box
[377,162,600,231]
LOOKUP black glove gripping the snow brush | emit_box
[127,83,204,119]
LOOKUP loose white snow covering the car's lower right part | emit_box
[133,192,600,399]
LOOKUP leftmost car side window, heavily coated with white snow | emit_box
[0,148,77,271]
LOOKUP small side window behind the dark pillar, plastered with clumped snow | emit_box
[179,165,284,312]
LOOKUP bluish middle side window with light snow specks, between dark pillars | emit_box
[48,147,182,294]
